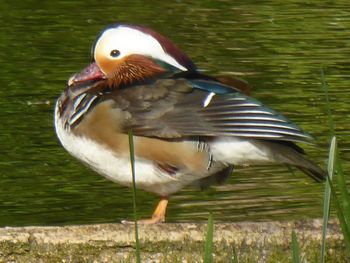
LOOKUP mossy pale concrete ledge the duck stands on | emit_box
[0,219,346,262]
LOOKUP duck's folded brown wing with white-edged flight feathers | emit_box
[113,79,312,142]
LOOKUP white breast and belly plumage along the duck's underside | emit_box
[55,103,203,195]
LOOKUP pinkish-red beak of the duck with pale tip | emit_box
[68,62,106,86]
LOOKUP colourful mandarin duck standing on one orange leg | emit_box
[55,23,326,224]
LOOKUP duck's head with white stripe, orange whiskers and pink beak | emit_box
[68,24,196,86]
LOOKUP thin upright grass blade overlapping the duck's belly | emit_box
[128,129,141,263]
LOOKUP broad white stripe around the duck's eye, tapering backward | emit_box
[94,26,188,71]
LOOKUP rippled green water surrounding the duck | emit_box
[0,0,350,226]
